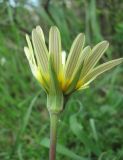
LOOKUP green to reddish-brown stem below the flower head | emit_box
[49,113,58,160]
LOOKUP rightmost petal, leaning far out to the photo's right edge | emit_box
[82,58,123,84]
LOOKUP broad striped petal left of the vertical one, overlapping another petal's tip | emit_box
[32,29,48,74]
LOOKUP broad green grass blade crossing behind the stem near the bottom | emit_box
[40,138,90,160]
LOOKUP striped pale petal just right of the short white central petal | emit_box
[65,33,85,81]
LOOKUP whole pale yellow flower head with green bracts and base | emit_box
[24,26,123,111]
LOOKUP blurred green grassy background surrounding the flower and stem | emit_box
[0,0,123,160]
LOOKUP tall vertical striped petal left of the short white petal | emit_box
[49,26,62,76]
